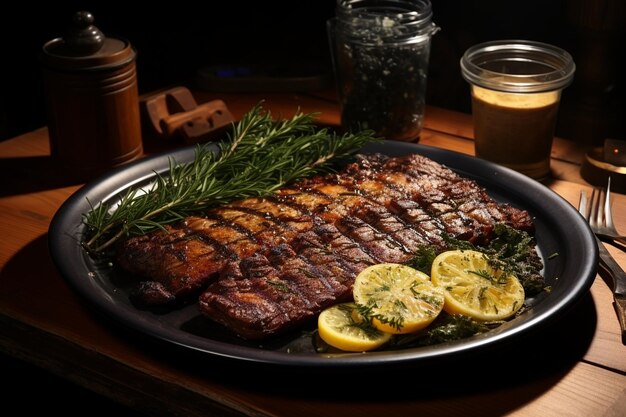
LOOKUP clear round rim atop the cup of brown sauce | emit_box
[461,40,576,93]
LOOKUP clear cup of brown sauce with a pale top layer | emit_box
[461,40,576,180]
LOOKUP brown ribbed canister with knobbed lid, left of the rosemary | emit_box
[41,12,143,174]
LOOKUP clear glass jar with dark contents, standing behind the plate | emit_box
[328,0,439,142]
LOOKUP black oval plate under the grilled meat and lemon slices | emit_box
[49,142,597,368]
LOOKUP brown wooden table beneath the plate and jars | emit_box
[0,92,626,417]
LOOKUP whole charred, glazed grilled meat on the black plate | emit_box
[117,154,534,339]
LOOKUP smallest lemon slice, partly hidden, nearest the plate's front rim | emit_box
[317,303,391,352]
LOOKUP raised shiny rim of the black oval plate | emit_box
[48,141,598,368]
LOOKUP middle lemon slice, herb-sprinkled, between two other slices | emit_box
[352,263,444,334]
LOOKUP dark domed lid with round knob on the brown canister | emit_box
[42,11,135,70]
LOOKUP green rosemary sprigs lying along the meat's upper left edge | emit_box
[82,103,377,255]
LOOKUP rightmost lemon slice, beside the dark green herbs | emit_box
[431,250,524,321]
